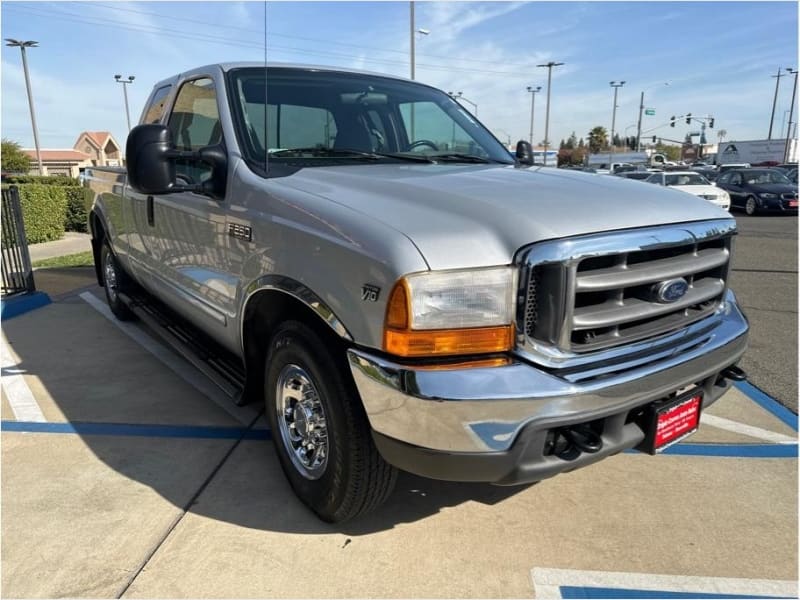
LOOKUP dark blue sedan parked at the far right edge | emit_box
[717,169,797,215]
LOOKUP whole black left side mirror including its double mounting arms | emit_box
[125,124,228,199]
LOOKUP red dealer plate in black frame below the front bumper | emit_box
[638,390,703,454]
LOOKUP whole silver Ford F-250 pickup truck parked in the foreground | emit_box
[88,64,748,521]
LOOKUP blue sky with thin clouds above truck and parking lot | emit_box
[0,0,798,148]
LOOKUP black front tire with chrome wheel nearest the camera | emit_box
[264,321,397,523]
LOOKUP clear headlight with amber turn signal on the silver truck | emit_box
[383,267,517,356]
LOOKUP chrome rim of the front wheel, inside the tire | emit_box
[275,364,328,479]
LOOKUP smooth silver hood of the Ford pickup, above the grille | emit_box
[280,164,730,269]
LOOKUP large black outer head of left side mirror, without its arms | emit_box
[125,124,175,194]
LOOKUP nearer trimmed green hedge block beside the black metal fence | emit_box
[3,184,67,244]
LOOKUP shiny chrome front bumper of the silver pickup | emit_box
[348,292,748,454]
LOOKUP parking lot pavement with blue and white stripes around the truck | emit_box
[0,223,798,598]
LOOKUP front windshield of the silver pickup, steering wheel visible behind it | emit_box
[228,67,514,167]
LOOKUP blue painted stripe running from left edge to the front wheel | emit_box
[0,421,271,440]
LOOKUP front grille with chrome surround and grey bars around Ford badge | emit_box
[518,219,736,362]
